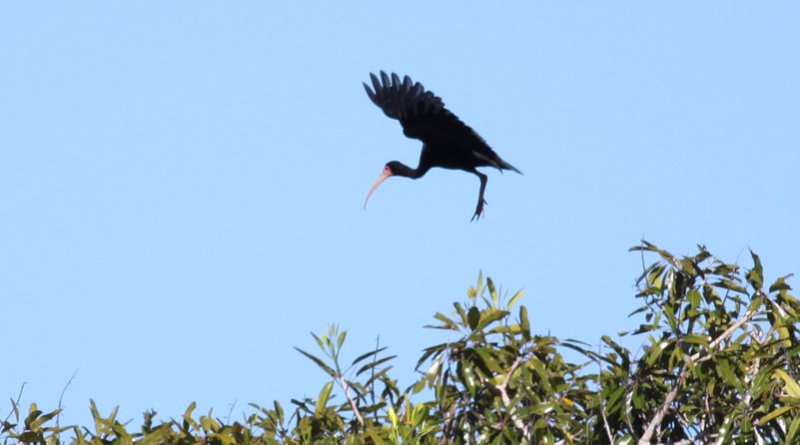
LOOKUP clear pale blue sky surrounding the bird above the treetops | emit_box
[0,2,800,423]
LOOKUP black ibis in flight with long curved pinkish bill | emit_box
[364,71,522,220]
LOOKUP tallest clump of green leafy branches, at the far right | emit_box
[597,242,800,443]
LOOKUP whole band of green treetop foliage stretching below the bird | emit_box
[0,242,800,445]
